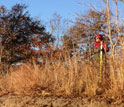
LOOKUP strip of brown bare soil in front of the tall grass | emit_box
[0,95,124,107]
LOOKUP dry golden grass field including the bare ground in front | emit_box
[0,54,124,107]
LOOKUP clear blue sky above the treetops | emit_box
[0,0,102,21]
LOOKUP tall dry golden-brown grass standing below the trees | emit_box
[0,53,124,101]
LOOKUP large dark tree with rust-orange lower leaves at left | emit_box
[0,4,54,71]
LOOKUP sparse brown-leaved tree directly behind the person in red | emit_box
[63,9,108,59]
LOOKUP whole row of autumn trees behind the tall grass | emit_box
[0,0,124,70]
